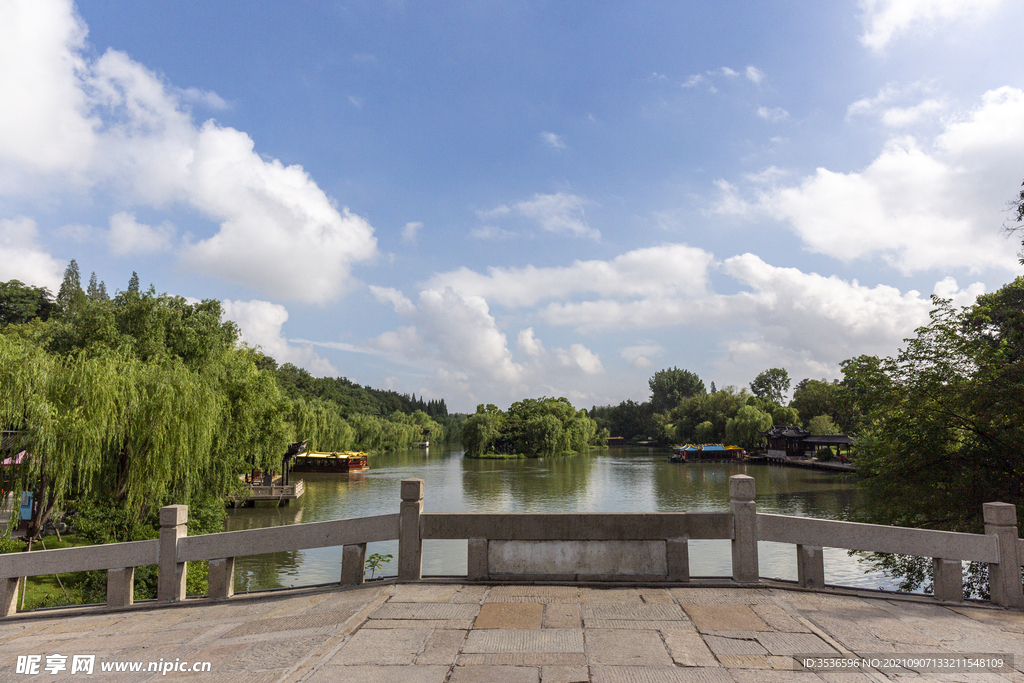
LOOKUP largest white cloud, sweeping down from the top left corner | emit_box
[0,0,377,303]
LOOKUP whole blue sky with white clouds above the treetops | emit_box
[0,0,1024,411]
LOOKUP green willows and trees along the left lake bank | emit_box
[0,261,456,597]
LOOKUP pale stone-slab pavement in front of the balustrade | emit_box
[0,583,1024,683]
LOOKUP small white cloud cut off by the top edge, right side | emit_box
[859,0,1001,50]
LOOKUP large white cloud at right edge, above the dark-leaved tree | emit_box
[715,87,1024,273]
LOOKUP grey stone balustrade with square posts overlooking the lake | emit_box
[0,474,1024,616]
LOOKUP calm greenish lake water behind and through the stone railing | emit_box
[227,444,894,592]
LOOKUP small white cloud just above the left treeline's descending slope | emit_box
[221,299,338,377]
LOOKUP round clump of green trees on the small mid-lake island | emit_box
[462,397,607,458]
